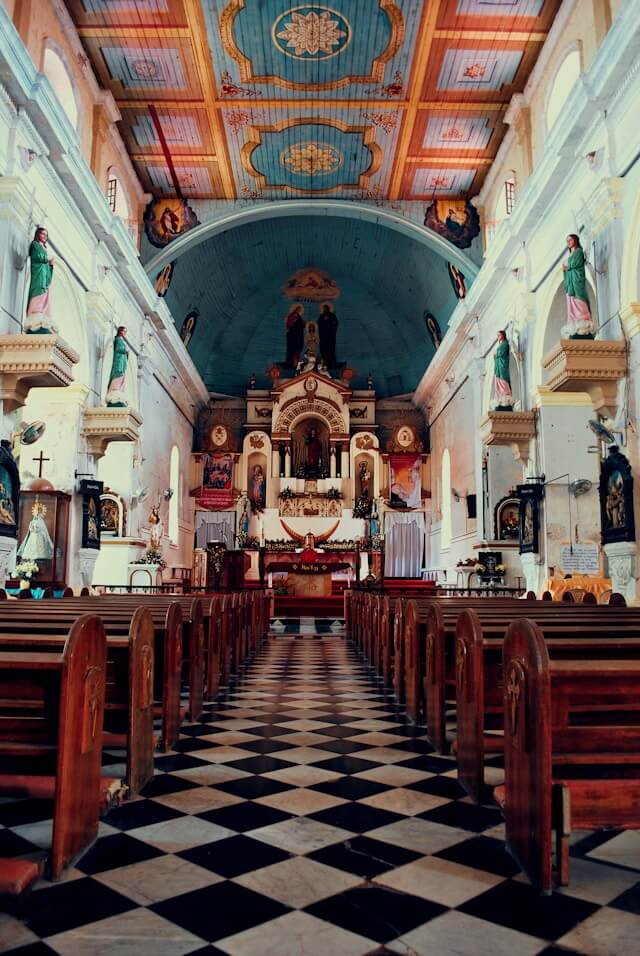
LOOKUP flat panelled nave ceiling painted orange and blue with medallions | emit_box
[67,0,560,200]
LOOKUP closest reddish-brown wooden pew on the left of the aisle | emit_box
[0,615,106,879]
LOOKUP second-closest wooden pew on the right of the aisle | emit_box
[454,609,640,801]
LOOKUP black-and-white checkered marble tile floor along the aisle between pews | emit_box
[0,619,640,956]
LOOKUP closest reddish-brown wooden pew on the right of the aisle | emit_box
[496,620,640,893]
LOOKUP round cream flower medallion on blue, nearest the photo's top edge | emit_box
[271,3,351,60]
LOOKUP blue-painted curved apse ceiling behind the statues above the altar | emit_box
[160,216,456,397]
